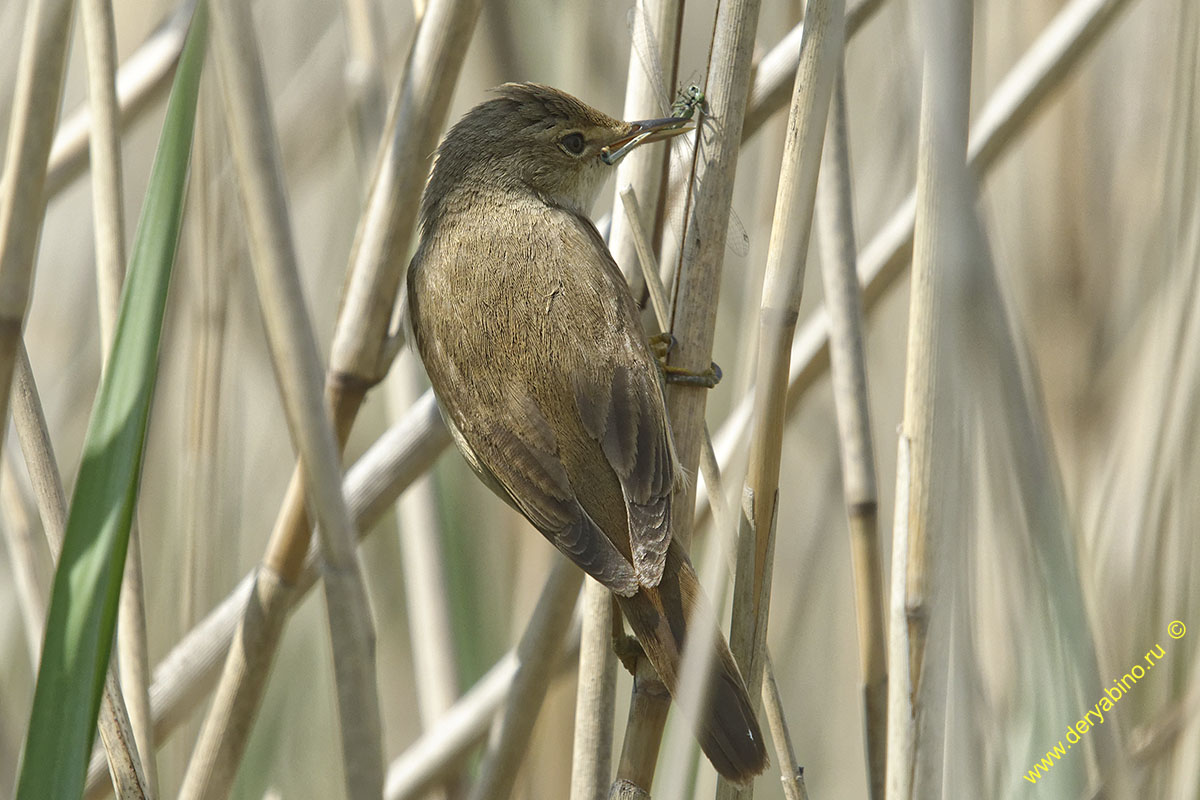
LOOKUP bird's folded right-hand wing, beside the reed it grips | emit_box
[574,212,678,587]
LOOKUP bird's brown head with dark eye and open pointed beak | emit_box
[424,83,694,218]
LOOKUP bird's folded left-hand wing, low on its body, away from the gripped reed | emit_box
[450,383,638,596]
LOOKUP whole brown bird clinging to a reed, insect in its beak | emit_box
[407,83,768,784]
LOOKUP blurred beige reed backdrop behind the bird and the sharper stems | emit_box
[0,0,1200,799]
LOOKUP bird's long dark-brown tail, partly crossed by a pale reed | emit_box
[618,542,767,784]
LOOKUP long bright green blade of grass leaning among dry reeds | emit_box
[17,4,206,800]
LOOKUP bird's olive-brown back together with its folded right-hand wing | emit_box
[408,197,676,583]
